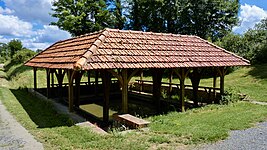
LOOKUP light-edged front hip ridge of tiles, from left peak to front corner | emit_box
[73,28,110,70]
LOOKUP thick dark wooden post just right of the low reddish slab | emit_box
[152,69,164,112]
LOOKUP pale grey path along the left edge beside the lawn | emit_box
[0,64,43,150]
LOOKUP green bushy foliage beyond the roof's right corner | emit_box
[217,18,267,63]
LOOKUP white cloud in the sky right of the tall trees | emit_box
[233,4,267,33]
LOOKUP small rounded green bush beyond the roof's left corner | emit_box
[12,49,36,63]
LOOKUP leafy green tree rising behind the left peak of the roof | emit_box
[51,0,114,36]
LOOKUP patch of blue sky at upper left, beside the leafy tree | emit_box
[3,0,56,24]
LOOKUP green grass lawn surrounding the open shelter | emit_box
[0,62,267,149]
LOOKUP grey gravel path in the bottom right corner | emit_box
[196,121,267,150]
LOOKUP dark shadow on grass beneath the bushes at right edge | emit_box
[248,64,267,79]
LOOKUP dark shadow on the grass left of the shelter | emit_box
[11,89,73,128]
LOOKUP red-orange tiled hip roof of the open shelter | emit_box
[25,29,249,70]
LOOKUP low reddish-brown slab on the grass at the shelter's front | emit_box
[113,114,150,128]
